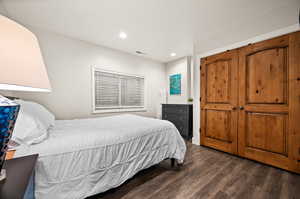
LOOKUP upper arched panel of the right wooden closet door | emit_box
[245,47,288,104]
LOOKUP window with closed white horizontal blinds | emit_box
[93,68,144,112]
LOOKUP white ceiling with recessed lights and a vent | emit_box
[0,0,300,62]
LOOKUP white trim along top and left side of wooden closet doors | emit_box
[193,24,300,144]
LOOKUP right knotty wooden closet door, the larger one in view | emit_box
[238,35,300,173]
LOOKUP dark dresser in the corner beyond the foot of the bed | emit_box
[162,104,193,140]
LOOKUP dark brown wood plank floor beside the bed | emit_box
[89,143,300,199]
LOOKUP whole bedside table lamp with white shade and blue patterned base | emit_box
[0,15,51,181]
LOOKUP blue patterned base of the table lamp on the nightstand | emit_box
[0,96,20,177]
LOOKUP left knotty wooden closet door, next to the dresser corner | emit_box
[200,50,238,154]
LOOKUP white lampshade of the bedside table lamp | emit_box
[0,15,51,92]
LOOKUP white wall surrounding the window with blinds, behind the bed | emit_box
[14,27,166,119]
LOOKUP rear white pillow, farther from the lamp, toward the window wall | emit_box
[15,100,55,130]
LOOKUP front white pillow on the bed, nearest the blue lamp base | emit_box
[11,106,48,145]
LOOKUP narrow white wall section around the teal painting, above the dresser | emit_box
[166,57,191,104]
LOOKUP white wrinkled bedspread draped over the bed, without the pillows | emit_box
[16,115,186,199]
